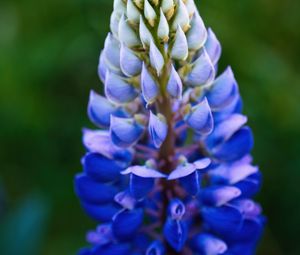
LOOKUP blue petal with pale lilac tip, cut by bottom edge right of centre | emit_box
[192,233,227,255]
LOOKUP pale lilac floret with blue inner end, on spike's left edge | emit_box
[83,129,132,163]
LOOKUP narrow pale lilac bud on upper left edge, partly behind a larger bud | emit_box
[104,33,120,70]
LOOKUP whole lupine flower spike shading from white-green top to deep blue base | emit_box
[75,0,265,255]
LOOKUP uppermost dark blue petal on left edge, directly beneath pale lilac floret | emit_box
[83,153,123,182]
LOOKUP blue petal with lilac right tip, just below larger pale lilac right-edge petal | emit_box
[200,186,242,206]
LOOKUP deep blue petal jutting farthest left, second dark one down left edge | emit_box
[75,174,118,204]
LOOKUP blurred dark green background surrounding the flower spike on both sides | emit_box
[0,0,300,255]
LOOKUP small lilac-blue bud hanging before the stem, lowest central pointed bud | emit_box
[149,111,168,148]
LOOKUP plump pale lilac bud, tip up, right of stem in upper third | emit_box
[186,49,215,87]
